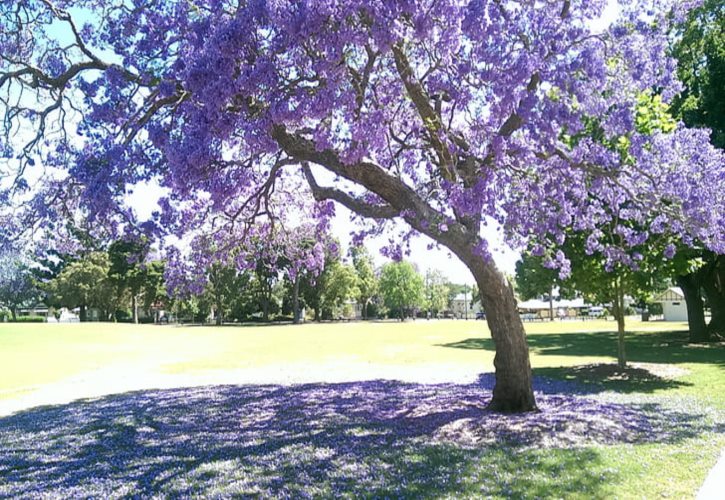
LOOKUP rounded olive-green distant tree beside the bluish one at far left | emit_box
[48,252,121,321]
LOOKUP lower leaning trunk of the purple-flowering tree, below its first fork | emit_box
[457,249,537,412]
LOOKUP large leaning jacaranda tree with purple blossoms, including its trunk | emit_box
[0,0,725,411]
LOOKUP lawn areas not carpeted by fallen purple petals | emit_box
[0,321,725,498]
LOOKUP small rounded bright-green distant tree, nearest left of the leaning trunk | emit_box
[380,261,425,321]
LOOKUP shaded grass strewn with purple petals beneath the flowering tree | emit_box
[0,375,713,498]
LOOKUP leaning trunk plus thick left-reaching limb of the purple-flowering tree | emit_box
[272,132,536,412]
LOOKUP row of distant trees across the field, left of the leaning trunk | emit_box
[0,239,478,324]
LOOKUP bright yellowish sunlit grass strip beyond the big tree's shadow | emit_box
[0,321,682,398]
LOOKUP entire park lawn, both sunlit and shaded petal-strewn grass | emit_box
[0,321,725,498]
